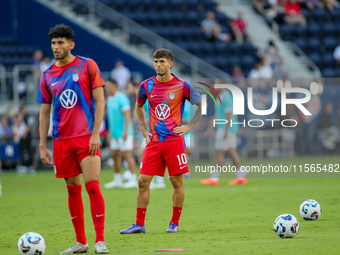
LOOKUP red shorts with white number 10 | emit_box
[139,138,189,176]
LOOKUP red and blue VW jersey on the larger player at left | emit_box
[37,56,105,139]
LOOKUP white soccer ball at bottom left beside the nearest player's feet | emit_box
[18,232,46,255]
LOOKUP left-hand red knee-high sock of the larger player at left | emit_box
[67,185,86,244]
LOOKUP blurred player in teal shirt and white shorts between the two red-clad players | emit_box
[104,79,138,188]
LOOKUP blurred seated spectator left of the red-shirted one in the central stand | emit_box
[201,11,230,42]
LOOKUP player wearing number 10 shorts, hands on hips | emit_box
[120,49,202,234]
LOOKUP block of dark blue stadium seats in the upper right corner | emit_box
[253,0,340,78]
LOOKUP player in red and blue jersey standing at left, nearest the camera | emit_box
[37,24,109,254]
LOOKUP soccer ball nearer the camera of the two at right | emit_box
[273,213,300,238]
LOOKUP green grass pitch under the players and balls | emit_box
[0,154,340,255]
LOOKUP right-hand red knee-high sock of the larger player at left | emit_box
[85,181,105,243]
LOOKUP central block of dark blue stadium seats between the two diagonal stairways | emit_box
[69,0,258,74]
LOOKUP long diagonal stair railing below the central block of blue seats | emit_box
[59,0,230,78]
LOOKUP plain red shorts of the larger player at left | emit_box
[53,135,100,178]
